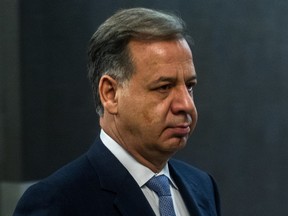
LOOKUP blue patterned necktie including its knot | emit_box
[146,175,176,216]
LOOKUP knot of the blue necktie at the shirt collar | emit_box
[146,175,171,197]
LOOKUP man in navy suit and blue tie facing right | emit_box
[14,8,220,216]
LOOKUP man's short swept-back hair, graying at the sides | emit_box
[88,8,189,116]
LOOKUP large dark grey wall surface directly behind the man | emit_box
[2,0,288,216]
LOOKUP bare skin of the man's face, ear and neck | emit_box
[99,39,197,173]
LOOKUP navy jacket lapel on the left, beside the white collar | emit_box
[88,139,155,216]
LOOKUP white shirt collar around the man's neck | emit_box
[100,129,177,189]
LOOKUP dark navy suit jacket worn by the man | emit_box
[13,139,220,216]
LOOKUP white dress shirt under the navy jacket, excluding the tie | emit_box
[100,129,189,216]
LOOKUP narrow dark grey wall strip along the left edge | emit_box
[0,0,21,181]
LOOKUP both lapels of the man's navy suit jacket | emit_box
[87,139,210,216]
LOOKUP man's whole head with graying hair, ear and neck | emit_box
[89,8,197,172]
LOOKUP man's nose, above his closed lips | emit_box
[171,85,197,117]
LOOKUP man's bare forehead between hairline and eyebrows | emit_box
[128,39,195,79]
